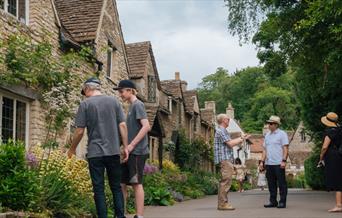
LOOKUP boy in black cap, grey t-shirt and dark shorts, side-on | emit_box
[115,80,150,218]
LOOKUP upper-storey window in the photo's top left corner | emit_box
[0,0,28,24]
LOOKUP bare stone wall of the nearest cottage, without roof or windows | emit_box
[0,0,129,150]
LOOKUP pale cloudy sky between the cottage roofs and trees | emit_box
[117,0,259,89]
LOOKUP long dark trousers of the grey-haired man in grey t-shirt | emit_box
[88,155,125,218]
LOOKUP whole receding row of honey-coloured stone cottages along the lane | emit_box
[0,0,215,168]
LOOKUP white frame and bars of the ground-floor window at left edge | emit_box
[0,91,30,149]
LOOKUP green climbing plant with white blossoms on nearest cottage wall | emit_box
[0,35,91,147]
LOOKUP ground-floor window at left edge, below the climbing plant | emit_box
[0,96,28,143]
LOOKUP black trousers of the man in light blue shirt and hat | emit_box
[266,165,287,204]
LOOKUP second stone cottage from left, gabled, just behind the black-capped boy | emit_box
[126,42,170,164]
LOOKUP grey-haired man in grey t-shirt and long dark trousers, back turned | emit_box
[68,78,128,218]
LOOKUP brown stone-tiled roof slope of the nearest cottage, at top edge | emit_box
[54,0,104,42]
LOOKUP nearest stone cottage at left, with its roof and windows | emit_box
[0,0,129,148]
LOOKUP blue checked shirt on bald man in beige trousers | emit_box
[214,127,234,164]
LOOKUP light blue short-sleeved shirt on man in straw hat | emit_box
[264,129,289,165]
